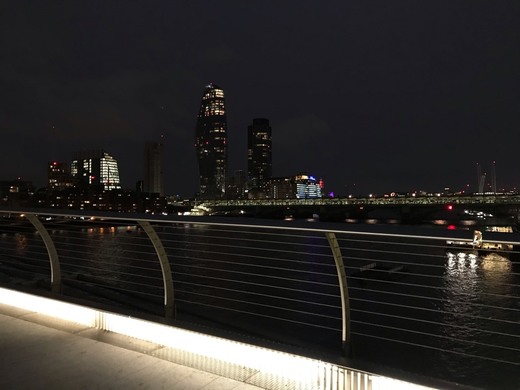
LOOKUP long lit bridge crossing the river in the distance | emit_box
[194,193,520,225]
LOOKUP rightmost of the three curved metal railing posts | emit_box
[325,232,351,357]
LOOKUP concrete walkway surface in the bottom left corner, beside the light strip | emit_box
[0,305,259,390]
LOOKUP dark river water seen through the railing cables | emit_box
[0,219,520,389]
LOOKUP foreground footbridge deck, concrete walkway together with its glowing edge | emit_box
[0,288,442,390]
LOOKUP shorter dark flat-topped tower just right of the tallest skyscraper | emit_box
[247,118,273,188]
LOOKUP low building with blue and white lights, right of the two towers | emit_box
[265,175,323,199]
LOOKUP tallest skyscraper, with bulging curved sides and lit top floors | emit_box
[195,84,227,199]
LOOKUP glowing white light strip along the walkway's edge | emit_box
[0,288,434,390]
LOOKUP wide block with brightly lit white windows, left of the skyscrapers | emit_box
[70,150,121,191]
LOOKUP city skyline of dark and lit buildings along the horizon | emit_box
[2,83,516,199]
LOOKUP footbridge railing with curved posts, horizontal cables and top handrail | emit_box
[0,210,520,383]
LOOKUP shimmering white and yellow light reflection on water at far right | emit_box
[441,248,520,386]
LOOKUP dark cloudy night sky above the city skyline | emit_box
[0,0,520,196]
